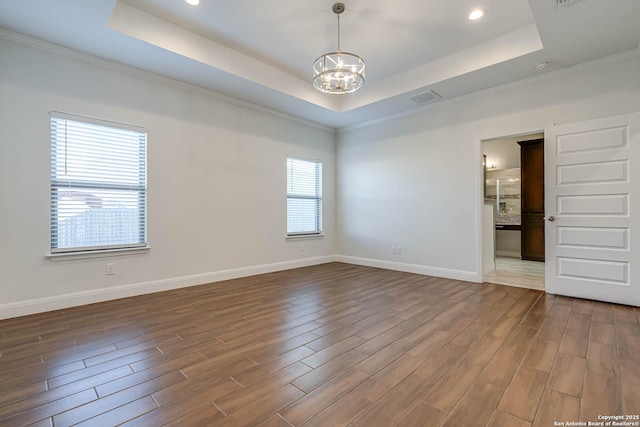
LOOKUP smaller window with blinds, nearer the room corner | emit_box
[287,157,322,236]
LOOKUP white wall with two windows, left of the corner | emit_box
[0,40,336,318]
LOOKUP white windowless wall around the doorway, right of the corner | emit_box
[337,55,640,281]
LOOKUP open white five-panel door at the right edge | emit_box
[544,113,640,306]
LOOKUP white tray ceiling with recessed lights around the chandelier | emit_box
[0,0,640,128]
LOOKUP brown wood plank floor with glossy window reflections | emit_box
[0,263,640,427]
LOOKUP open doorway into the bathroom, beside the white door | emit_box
[482,132,545,290]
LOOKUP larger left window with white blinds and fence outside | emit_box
[51,112,147,253]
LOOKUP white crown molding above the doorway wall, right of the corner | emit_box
[336,48,640,134]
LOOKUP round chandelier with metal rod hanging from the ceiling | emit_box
[313,3,364,95]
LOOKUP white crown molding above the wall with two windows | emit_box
[0,27,335,135]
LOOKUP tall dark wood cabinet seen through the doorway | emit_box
[518,139,544,261]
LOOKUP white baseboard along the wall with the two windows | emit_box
[0,255,337,319]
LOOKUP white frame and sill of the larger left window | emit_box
[46,111,149,259]
